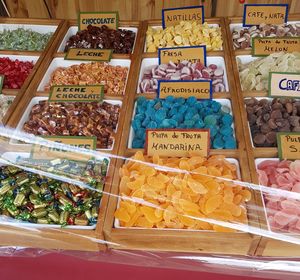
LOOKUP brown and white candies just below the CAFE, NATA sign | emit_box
[232,23,300,49]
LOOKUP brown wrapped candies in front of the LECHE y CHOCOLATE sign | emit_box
[23,100,120,149]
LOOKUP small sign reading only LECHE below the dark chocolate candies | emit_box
[65,48,112,61]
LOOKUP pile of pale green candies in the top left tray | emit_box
[0,28,53,51]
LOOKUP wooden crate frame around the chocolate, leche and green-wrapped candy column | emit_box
[0,21,143,251]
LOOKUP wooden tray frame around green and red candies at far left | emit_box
[0,18,65,125]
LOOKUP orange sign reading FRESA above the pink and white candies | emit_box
[158,46,206,66]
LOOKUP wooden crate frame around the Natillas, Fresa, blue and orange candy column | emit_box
[104,19,260,255]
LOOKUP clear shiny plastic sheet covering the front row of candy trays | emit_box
[0,127,300,279]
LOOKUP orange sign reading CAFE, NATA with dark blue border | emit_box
[243,4,288,26]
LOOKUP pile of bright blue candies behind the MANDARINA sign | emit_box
[131,96,236,149]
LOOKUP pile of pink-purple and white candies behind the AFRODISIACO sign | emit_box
[140,60,225,93]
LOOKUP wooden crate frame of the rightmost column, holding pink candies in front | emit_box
[225,14,300,257]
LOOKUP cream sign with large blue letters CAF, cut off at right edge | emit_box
[269,72,300,98]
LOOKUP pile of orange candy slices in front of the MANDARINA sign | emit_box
[115,152,251,232]
